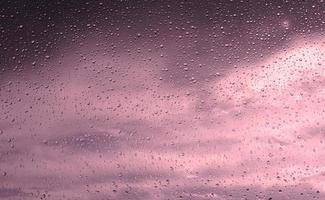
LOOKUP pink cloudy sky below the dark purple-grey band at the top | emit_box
[0,35,325,200]
